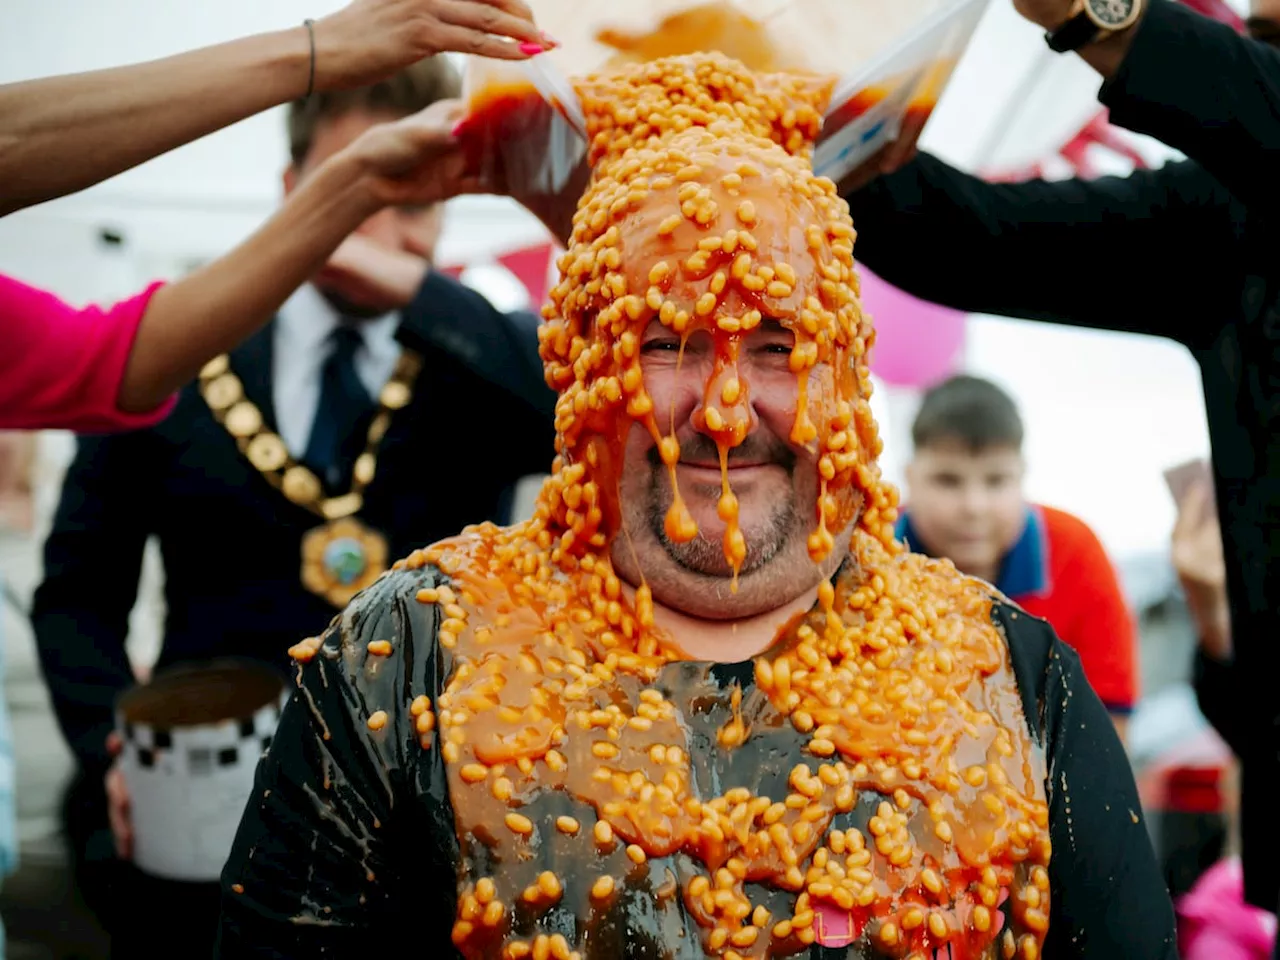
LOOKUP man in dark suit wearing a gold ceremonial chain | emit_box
[33,58,554,957]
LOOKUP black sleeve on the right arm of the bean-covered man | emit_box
[995,604,1178,960]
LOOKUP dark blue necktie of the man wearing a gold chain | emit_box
[302,326,374,489]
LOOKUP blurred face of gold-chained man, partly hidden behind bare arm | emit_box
[284,110,444,315]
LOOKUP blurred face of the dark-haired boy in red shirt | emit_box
[906,440,1025,580]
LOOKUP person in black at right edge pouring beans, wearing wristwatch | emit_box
[844,0,1280,910]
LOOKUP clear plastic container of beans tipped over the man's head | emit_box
[460,0,989,225]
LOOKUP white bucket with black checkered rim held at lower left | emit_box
[116,660,288,882]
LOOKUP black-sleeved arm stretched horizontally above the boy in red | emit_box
[847,154,1239,353]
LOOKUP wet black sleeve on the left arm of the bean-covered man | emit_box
[215,570,457,960]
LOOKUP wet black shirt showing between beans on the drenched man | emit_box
[218,567,1176,960]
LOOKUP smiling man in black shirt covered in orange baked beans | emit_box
[220,50,1176,960]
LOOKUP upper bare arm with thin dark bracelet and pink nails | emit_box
[0,0,544,216]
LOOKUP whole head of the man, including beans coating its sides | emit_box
[543,124,901,617]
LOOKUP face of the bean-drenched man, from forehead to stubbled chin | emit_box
[573,142,856,617]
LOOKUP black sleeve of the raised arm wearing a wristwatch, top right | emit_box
[1100,0,1280,214]
